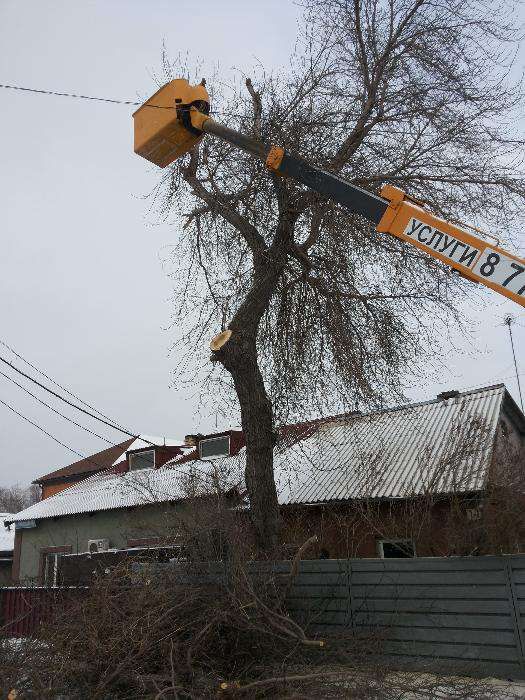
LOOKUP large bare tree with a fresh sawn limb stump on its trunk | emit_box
[161,0,525,549]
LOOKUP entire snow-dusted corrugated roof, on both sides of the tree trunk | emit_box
[8,385,505,522]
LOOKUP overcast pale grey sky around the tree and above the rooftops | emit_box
[0,0,525,485]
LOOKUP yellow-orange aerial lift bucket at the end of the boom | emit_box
[133,78,210,168]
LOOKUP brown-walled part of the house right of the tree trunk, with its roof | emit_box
[175,384,525,558]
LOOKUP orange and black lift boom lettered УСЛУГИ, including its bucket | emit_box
[133,79,525,307]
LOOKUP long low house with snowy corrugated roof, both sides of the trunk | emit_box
[6,384,525,584]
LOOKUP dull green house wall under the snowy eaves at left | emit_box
[16,504,180,583]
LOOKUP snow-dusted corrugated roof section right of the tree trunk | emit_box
[274,385,505,504]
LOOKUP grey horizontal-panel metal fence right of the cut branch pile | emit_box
[284,555,525,678]
